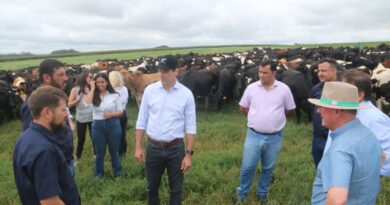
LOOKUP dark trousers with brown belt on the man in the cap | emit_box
[145,141,185,205]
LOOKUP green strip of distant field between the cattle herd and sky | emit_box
[0,41,390,70]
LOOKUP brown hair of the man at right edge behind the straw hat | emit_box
[342,69,372,100]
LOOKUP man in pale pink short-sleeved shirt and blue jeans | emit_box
[236,60,295,204]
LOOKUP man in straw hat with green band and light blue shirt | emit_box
[309,82,382,205]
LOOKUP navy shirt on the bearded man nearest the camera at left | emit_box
[13,122,80,205]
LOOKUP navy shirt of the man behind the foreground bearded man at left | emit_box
[20,98,74,163]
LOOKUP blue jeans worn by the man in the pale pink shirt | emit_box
[236,128,282,199]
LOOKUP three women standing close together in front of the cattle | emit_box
[68,66,129,177]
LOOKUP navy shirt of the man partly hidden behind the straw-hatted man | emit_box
[310,83,328,139]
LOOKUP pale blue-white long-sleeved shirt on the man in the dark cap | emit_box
[136,81,196,142]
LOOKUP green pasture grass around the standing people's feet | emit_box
[0,102,390,205]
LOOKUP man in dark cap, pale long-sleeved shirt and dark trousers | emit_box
[135,55,196,205]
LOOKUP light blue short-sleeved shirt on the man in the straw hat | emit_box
[311,119,382,205]
